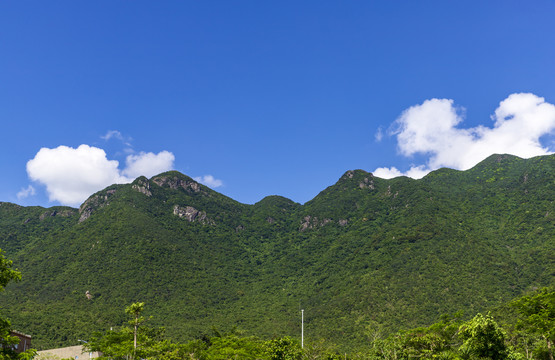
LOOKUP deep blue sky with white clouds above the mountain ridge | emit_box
[0,0,555,206]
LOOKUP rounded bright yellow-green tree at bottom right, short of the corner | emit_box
[459,314,509,360]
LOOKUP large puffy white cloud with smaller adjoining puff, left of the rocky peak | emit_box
[27,145,173,206]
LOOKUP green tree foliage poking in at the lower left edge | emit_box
[0,249,36,360]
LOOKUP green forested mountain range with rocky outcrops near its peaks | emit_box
[0,155,555,348]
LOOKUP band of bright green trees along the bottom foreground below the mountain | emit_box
[80,288,555,360]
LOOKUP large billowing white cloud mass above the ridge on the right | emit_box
[374,93,555,178]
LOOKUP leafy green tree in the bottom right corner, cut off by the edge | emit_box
[513,288,555,360]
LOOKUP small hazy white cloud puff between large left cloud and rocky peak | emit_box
[123,151,175,179]
